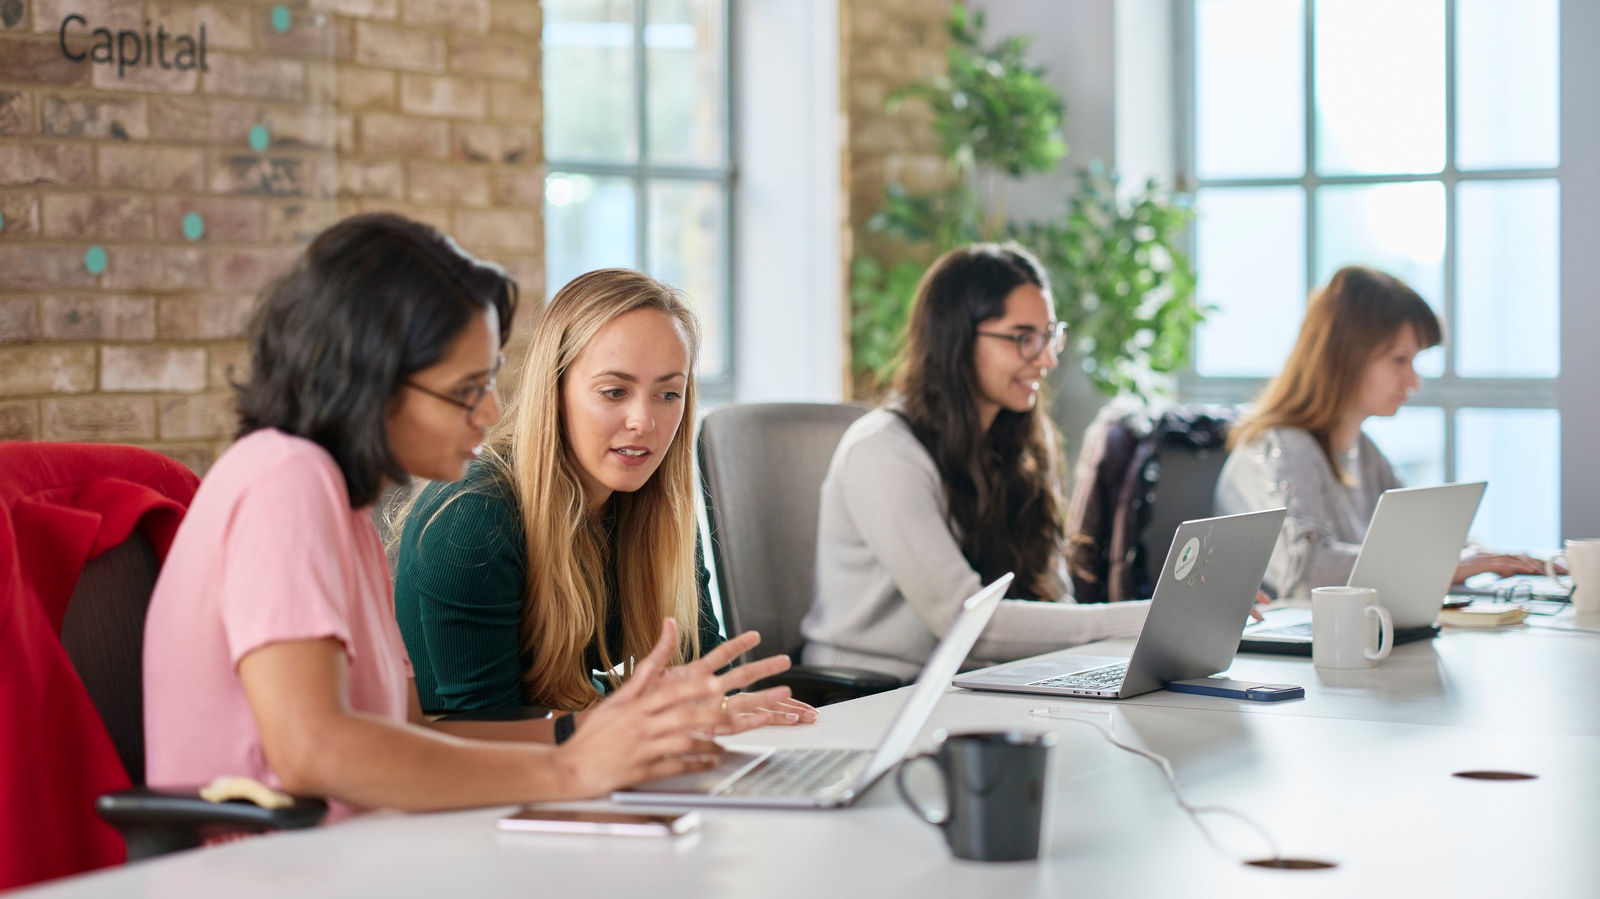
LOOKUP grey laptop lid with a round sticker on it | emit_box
[1117,509,1285,696]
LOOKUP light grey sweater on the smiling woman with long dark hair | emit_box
[800,408,1149,680]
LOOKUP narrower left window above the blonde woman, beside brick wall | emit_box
[542,0,733,392]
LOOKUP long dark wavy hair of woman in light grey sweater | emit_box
[894,243,1064,600]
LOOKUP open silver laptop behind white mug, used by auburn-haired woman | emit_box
[1238,481,1485,656]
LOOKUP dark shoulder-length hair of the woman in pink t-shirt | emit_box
[234,214,517,509]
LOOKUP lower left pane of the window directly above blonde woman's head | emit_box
[544,171,638,296]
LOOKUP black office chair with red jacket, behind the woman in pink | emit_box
[61,531,328,861]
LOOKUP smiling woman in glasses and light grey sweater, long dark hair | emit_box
[802,243,1149,678]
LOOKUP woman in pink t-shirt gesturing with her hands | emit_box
[144,214,787,814]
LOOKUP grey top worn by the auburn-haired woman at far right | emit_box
[1216,427,1402,598]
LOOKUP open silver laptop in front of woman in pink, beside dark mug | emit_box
[611,574,1013,808]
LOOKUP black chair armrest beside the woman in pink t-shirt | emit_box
[94,787,328,862]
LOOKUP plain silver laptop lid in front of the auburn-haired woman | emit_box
[1349,481,1486,629]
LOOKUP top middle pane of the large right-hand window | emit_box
[1315,0,1445,174]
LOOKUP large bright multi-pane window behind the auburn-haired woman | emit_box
[1179,0,1560,549]
